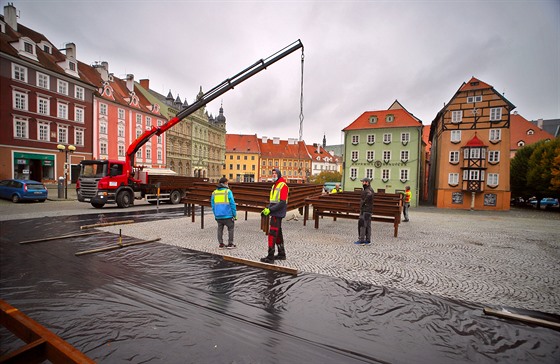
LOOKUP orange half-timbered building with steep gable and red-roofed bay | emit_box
[428,77,515,210]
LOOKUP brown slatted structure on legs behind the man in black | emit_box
[303,191,403,238]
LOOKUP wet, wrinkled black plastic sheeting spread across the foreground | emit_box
[0,212,560,364]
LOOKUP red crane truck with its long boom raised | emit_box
[76,39,303,208]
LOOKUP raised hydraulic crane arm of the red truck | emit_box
[126,39,303,167]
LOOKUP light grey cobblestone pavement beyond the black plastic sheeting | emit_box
[103,207,560,314]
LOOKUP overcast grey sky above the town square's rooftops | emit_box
[5,0,560,144]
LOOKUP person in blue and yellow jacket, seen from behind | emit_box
[210,177,237,249]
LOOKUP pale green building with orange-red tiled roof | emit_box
[342,100,423,206]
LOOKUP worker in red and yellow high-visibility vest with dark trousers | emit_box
[261,168,289,263]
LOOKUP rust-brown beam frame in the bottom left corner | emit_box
[0,300,95,364]
